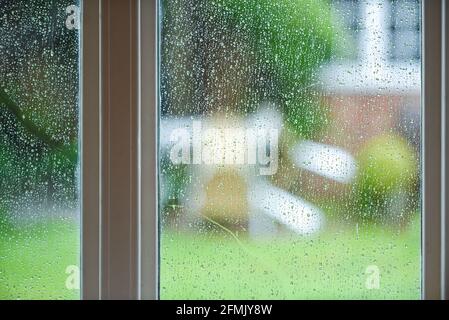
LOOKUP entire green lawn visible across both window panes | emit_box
[0,219,420,299]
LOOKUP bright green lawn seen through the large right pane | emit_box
[160,219,421,299]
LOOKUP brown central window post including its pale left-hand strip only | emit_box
[82,0,139,299]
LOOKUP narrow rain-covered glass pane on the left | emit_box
[0,0,80,299]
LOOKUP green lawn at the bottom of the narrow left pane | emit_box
[0,220,80,300]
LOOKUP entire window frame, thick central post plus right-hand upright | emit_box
[81,0,449,299]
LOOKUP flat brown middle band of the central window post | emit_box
[101,0,138,299]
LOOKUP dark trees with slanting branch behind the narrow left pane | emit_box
[0,0,79,218]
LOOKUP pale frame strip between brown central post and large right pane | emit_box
[139,0,159,299]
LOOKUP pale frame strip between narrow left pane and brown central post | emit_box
[80,1,101,300]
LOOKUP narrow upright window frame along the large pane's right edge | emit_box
[421,0,445,300]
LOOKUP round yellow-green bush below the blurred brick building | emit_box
[355,134,418,220]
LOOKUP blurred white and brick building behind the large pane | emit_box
[320,0,421,152]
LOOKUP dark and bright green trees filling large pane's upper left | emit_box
[161,0,338,137]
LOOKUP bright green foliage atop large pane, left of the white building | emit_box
[216,0,334,88]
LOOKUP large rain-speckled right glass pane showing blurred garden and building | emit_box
[159,0,421,299]
